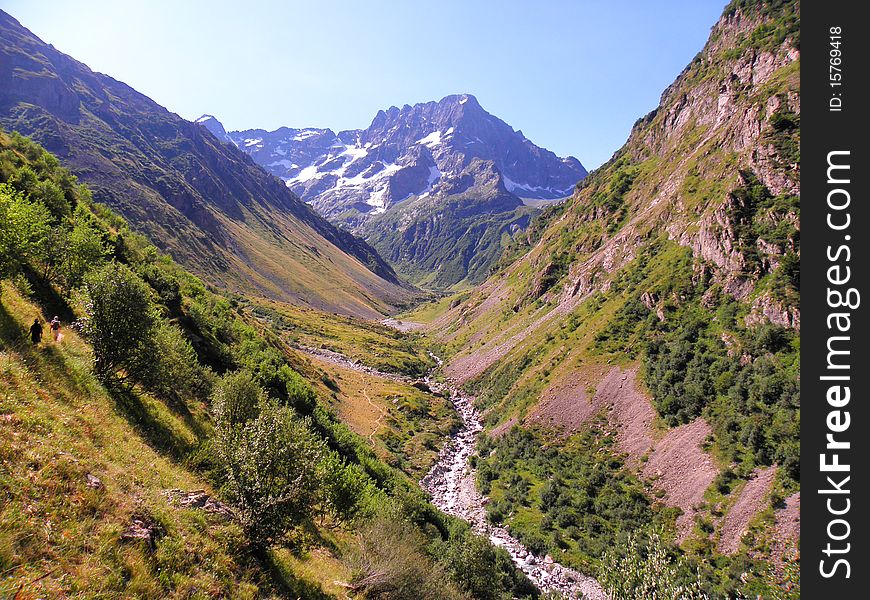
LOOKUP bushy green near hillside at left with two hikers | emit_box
[0,132,538,600]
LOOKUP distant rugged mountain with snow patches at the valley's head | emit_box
[212,94,586,288]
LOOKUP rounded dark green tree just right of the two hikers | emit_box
[82,262,157,381]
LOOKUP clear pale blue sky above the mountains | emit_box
[0,0,725,169]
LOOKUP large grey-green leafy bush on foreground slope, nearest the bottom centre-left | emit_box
[212,374,324,549]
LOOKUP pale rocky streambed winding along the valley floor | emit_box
[420,372,608,600]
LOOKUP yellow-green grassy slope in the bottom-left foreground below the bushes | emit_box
[0,285,344,598]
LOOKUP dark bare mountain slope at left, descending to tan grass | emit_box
[0,12,412,318]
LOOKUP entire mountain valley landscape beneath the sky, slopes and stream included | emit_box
[0,0,801,600]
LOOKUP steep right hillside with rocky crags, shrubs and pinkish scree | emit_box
[403,0,800,597]
